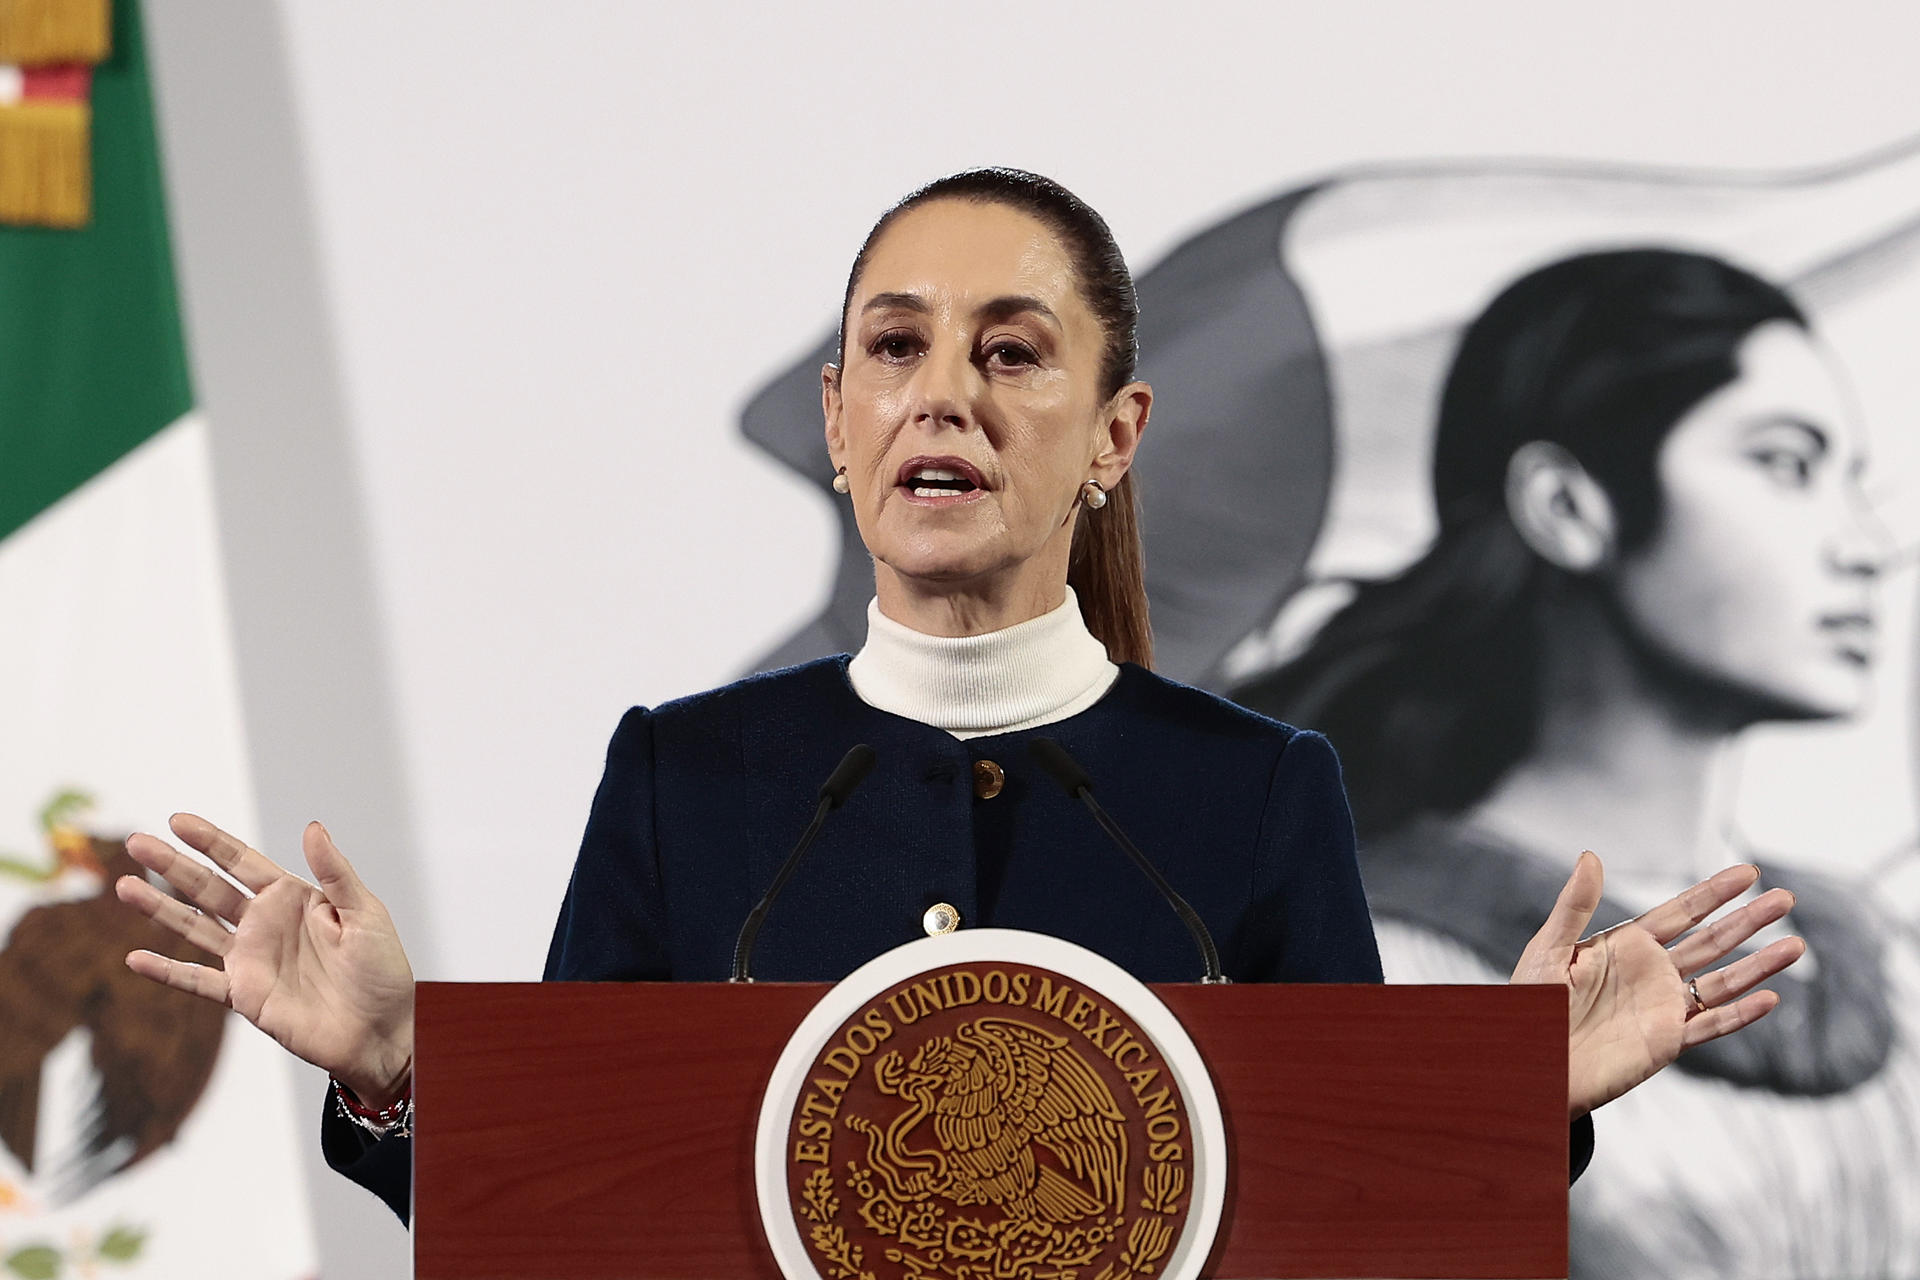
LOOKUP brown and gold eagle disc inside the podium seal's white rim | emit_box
[787,963,1192,1280]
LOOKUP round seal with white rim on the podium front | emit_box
[755,929,1227,1280]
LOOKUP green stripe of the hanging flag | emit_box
[0,0,194,537]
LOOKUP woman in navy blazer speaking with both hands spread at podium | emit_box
[119,169,1801,1213]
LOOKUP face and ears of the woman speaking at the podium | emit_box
[822,200,1150,603]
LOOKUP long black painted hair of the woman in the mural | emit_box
[1235,249,1807,835]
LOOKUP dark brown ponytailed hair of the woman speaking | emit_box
[839,169,1154,666]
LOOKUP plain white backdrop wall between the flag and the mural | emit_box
[148,0,1920,1276]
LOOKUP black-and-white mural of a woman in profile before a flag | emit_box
[743,142,1920,1280]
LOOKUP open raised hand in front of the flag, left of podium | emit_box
[115,814,413,1107]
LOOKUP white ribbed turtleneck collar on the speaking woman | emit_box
[847,587,1119,739]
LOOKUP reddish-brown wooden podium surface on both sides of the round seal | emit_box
[413,983,1567,1280]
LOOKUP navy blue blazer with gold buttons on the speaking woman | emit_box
[323,654,1589,1217]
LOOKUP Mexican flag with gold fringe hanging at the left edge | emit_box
[0,0,315,1280]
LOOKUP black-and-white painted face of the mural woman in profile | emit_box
[1615,322,1880,718]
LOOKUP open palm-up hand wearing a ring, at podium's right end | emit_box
[1511,852,1807,1117]
